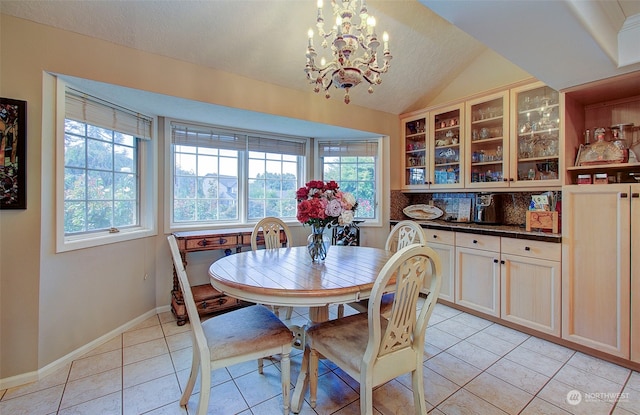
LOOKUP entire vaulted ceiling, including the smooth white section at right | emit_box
[0,0,640,133]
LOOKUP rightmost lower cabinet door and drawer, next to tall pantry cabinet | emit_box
[500,238,562,337]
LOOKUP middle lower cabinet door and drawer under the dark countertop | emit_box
[455,232,500,317]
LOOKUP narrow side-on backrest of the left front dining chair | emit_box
[167,235,211,362]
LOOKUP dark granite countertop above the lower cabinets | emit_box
[390,219,562,243]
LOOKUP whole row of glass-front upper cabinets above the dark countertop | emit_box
[401,82,564,190]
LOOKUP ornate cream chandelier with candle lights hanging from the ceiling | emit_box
[304,0,391,104]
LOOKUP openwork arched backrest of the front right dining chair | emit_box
[361,244,442,384]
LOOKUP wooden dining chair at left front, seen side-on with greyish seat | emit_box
[167,235,293,415]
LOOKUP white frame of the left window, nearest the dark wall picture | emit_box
[55,77,158,253]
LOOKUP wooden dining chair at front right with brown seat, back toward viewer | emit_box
[304,245,442,415]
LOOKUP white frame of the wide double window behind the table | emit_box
[164,118,312,233]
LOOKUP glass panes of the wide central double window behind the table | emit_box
[171,121,306,224]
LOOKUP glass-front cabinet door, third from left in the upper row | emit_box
[465,91,510,188]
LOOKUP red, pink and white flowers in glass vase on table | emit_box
[296,180,358,262]
